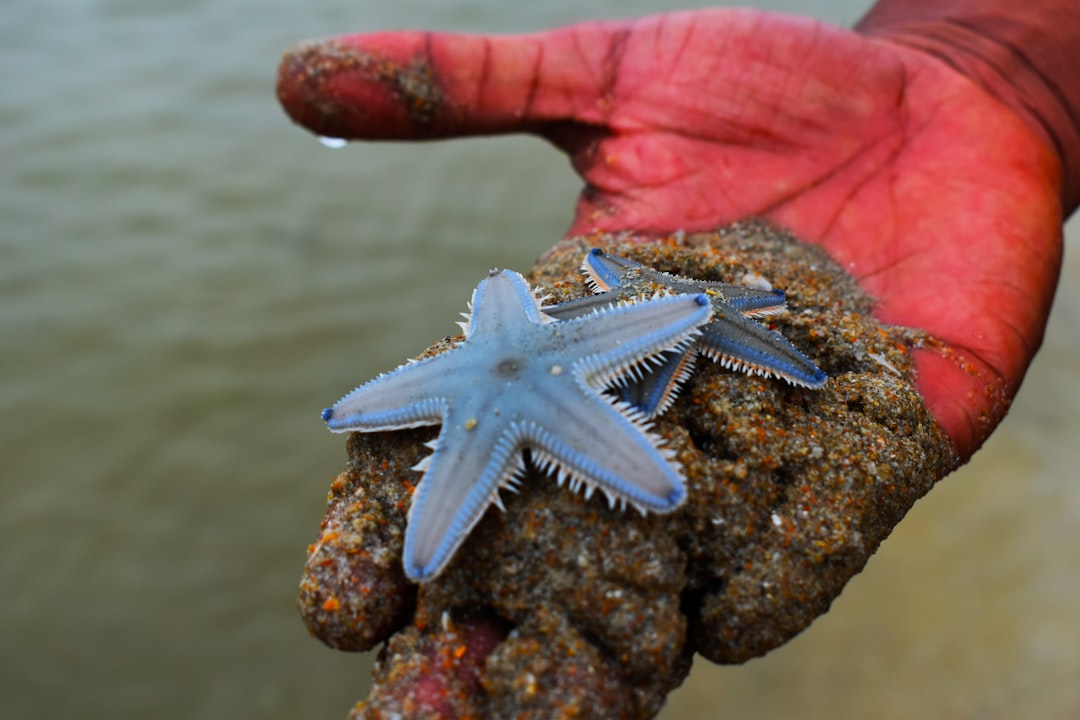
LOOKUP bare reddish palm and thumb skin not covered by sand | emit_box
[278,10,1063,708]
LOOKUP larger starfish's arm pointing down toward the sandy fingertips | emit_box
[404,412,523,582]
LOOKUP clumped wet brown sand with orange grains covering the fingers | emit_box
[299,223,956,718]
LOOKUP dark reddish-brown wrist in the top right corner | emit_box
[856,0,1080,215]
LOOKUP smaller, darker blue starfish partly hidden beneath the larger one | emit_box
[545,247,828,418]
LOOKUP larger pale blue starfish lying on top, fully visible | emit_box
[323,270,711,581]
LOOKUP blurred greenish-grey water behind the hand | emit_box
[0,0,1080,719]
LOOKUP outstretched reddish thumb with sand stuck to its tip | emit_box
[278,24,626,139]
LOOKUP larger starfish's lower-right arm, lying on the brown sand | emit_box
[523,385,686,513]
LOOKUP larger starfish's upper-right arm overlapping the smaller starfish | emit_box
[554,295,712,388]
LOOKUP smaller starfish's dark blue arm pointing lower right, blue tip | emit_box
[698,311,828,388]
